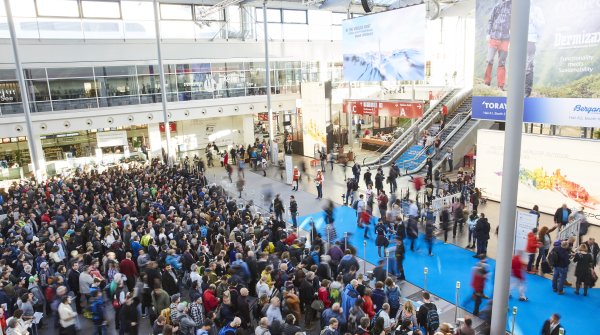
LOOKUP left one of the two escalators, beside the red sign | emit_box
[363,89,466,166]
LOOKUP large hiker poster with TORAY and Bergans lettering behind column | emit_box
[473,0,600,127]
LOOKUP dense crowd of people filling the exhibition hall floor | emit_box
[0,133,598,335]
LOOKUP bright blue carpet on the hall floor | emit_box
[298,206,600,335]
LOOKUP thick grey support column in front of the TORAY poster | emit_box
[491,0,531,335]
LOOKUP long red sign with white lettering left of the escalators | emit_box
[343,100,425,119]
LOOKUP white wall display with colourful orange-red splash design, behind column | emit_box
[476,130,600,226]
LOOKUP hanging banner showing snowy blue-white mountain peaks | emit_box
[342,5,425,81]
